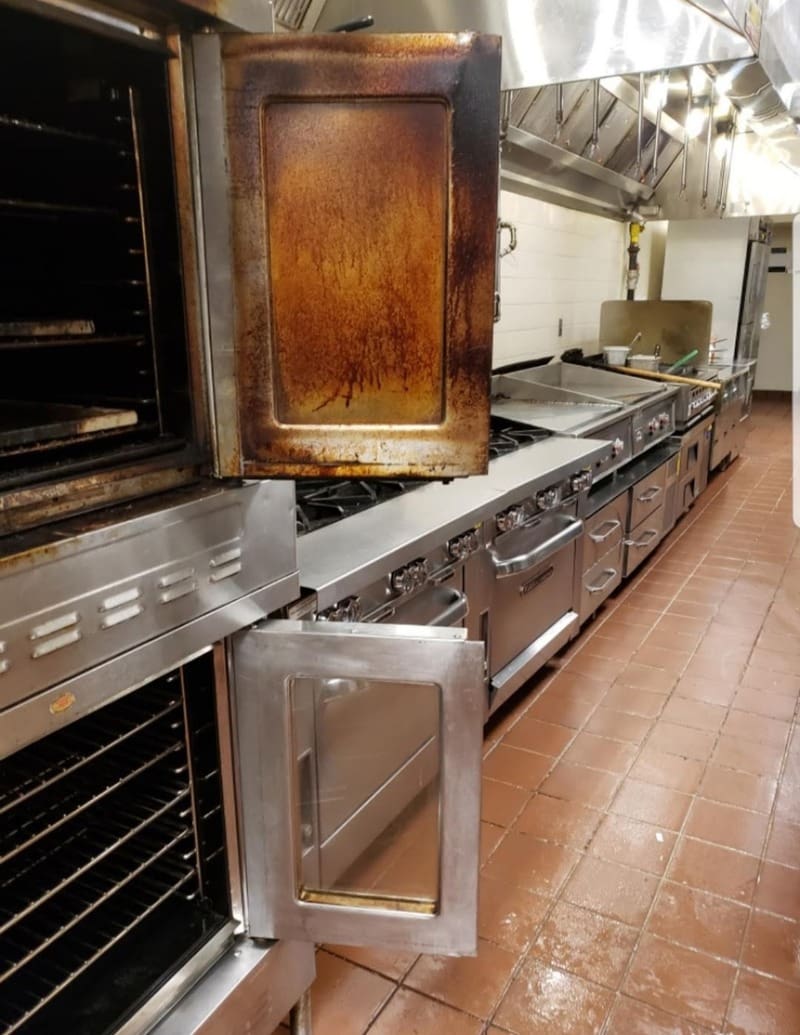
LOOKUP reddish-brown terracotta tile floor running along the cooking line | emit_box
[281,401,800,1035]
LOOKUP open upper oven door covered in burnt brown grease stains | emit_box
[192,33,500,478]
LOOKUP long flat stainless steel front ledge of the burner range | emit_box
[297,438,609,609]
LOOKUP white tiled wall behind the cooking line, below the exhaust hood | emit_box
[494,190,627,366]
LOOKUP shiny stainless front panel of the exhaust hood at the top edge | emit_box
[314,0,752,90]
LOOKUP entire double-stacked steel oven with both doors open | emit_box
[0,0,499,1035]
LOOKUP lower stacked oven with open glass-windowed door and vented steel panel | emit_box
[0,482,485,1035]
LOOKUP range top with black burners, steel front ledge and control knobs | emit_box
[291,421,610,620]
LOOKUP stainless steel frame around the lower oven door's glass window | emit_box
[233,620,484,955]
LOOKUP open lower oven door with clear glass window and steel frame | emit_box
[233,620,485,955]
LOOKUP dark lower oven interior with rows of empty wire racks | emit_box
[0,651,231,1035]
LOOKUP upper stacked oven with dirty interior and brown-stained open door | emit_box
[0,0,500,532]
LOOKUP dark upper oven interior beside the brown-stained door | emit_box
[0,8,191,492]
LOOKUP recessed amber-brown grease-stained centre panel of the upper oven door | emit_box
[263,99,449,424]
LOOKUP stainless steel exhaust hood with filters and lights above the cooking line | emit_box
[291,0,800,218]
